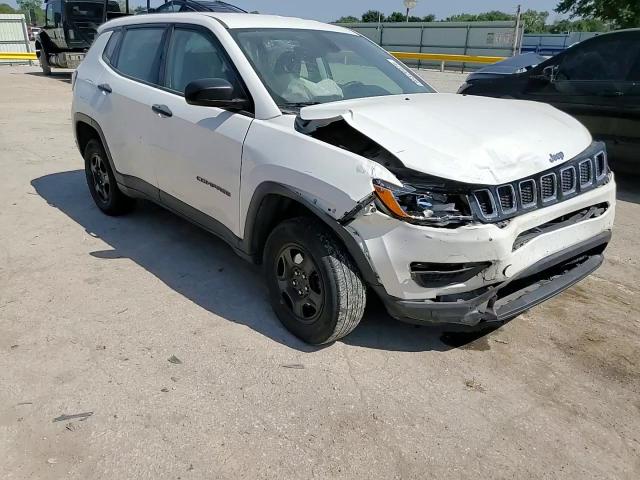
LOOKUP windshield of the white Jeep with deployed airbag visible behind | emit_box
[231,29,434,108]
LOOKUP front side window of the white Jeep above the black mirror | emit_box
[165,28,241,93]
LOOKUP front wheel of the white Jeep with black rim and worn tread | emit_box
[263,217,366,345]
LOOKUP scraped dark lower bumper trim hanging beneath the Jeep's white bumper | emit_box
[378,231,611,327]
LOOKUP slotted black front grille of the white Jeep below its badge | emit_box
[471,143,609,222]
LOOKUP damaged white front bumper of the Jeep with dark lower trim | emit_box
[349,172,616,326]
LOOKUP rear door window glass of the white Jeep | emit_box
[117,27,165,85]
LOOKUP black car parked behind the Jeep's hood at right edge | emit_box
[459,29,640,171]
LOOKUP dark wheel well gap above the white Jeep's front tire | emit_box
[250,193,322,263]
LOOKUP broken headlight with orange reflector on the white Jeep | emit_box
[373,178,474,228]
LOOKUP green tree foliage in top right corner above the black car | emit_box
[556,0,640,28]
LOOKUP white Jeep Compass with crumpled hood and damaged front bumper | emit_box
[72,13,615,344]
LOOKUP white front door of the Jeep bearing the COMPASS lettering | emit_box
[151,23,253,235]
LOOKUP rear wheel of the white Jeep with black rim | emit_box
[84,139,135,216]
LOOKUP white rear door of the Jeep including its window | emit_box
[96,24,168,192]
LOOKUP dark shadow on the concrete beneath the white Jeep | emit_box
[31,170,500,352]
